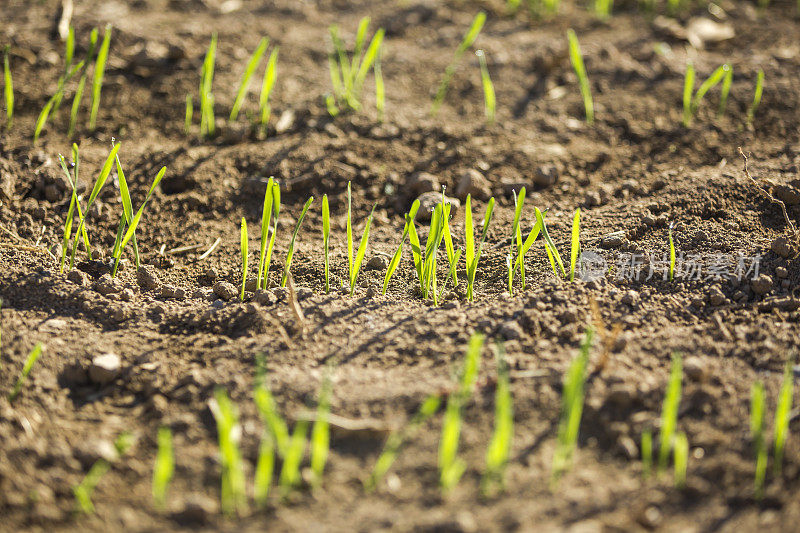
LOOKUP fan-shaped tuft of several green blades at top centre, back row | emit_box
[326,17,386,116]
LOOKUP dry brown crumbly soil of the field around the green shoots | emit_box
[0,0,800,531]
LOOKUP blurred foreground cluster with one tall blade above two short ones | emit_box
[641,353,689,488]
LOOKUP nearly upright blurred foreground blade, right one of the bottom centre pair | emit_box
[481,342,514,494]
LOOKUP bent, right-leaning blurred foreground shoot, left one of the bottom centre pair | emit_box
[439,333,485,492]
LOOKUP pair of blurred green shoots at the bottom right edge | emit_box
[750,359,794,500]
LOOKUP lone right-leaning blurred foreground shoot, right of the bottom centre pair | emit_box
[551,328,594,483]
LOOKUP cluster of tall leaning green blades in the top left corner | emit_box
[33,25,111,143]
